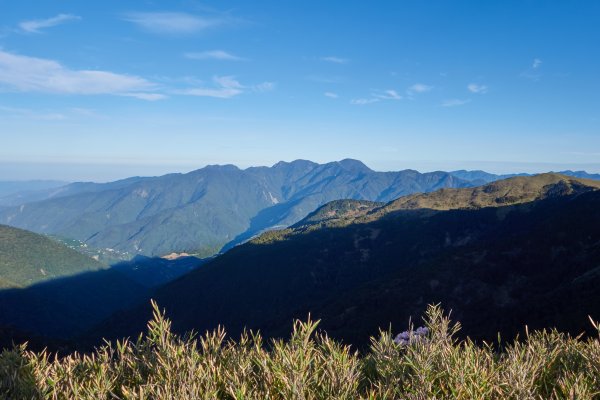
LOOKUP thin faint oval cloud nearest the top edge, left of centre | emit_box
[123,12,226,35]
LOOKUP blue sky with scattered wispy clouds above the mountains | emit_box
[0,0,600,180]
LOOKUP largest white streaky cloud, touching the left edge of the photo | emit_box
[0,50,164,100]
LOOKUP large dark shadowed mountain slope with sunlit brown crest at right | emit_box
[89,174,600,345]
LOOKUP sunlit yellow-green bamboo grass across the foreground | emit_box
[0,306,600,399]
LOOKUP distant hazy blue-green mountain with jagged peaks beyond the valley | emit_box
[0,159,472,256]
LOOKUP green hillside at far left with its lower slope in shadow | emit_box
[0,225,203,340]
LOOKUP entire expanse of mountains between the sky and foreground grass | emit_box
[0,160,600,345]
